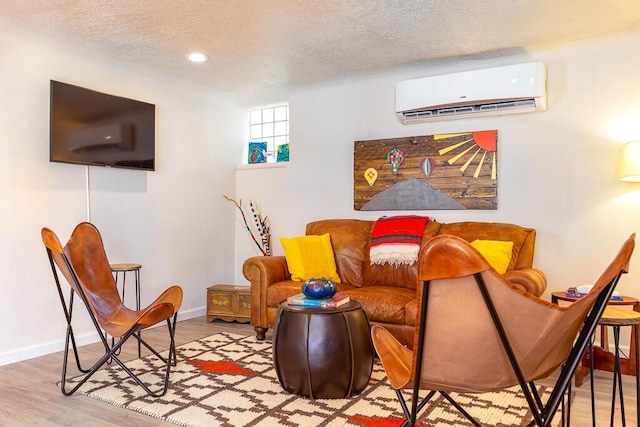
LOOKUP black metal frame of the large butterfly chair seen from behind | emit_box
[396,271,622,427]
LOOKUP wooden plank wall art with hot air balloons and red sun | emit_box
[353,130,498,211]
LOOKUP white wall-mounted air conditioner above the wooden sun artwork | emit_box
[396,62,547,123]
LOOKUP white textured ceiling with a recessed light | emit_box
[0,0,640,91]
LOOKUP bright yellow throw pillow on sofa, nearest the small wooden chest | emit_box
[280,233,340,283]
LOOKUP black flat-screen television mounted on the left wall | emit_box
[49,80,156,171]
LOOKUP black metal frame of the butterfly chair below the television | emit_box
[47,248,178,397]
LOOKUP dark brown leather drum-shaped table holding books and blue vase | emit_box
[273,301,373,399]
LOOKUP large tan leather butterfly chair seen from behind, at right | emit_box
[371,234,635,426]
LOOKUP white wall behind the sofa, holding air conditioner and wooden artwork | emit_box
[235,32,640,298]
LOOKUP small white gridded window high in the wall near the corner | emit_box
[250,104,289,163]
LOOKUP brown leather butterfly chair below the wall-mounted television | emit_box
[42,222,182,397]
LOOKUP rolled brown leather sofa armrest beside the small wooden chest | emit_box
[242,256,291,328]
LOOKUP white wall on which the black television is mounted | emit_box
[0,30,243,365]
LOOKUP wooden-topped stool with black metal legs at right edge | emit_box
[589,306,640,427]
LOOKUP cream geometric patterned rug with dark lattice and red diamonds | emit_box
[71,333,559,427]
